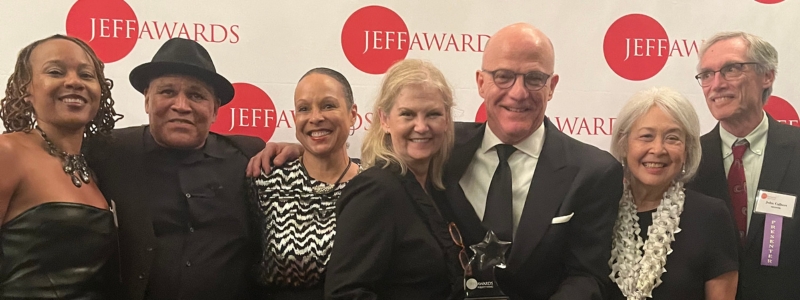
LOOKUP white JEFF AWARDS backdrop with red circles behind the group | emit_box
[0,0,800,157]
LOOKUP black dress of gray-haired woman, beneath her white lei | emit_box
[611,190,739,300]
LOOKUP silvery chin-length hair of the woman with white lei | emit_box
[611,87,702,182]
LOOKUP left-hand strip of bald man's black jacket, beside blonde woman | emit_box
[444,123,486,245]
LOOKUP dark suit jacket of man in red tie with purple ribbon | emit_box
[687,116,800,300]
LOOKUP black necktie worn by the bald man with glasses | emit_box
[483,144,517,242]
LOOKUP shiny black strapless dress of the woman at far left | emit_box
[0,202,116,300]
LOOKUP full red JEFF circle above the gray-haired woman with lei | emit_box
[603,14,670,81]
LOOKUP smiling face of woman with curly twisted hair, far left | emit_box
[25,39,100,130]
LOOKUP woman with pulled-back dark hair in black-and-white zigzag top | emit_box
[254,68,360,300]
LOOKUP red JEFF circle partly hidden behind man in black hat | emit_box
[211,82,278,142]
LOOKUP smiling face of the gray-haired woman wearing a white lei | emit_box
[625,106,686,192]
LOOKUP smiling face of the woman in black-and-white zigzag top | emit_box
[294,73,357,157]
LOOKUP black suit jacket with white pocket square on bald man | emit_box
[437,119,623,300]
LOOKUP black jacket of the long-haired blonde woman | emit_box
[325,166,454,300]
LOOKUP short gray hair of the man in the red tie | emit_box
[698,31,778,104]
